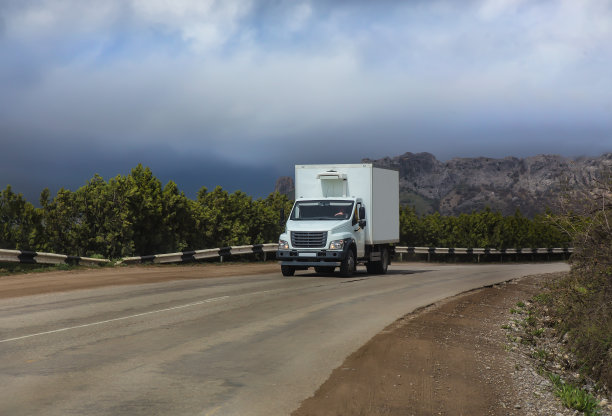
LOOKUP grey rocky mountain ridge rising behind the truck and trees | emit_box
[276,152,612,217]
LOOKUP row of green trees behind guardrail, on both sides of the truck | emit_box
[0,165,570,259]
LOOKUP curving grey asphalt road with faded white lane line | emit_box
[0,263,568,416]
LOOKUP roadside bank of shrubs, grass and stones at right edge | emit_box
[505,171,612,415]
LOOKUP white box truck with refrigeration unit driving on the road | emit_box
[276,164,399,276]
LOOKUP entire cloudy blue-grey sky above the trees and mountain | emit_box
[0,0,612,202]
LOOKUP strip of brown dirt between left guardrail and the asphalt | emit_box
[0,262,279,299]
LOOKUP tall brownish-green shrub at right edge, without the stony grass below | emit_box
[542,173,612,387]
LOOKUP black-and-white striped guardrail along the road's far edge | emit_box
[0,243,574,265]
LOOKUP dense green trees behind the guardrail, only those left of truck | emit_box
[0,165,291,259]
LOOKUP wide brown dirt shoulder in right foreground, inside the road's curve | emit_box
[292,275,572,416]
